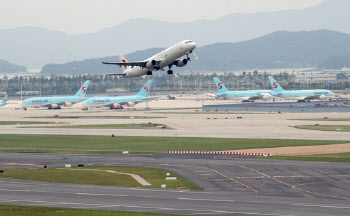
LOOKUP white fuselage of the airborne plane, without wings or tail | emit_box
[123,40,196,78]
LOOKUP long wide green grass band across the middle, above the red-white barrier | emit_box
[0,134,348,154]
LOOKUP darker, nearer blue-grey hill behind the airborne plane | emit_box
[42,30,350,74]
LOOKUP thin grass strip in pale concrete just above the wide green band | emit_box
[21,123,172,129]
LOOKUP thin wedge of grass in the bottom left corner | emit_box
[0,205,183,216]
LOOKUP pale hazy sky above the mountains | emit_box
[0,0,324,34]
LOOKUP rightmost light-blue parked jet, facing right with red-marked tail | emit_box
[269,76,334,100]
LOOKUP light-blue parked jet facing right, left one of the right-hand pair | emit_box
[214,77,273,100]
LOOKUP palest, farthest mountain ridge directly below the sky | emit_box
[0,0,350,68]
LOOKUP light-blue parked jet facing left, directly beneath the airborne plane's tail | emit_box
[83,80,152,109]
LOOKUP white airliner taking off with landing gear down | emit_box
[101,40,197,78]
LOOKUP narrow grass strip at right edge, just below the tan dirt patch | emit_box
[265,152,350,162]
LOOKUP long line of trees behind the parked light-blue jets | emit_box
[0,71,350,96]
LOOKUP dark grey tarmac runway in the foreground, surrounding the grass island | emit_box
[0,153,350,215]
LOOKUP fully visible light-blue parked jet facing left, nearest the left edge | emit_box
[21,80,90,110]
